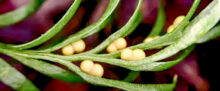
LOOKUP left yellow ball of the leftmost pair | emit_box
[62,45,74,56]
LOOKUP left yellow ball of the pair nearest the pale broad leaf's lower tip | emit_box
[121,48,133,61]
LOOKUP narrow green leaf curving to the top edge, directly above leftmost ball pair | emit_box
[39,0,120,52]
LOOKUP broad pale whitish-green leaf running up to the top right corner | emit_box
[135,0,220,65]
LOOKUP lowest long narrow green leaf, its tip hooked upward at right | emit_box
[0,45,176,91]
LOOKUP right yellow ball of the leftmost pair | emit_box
[72,40,86,53]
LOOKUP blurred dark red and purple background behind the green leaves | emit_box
[0,0,220,91]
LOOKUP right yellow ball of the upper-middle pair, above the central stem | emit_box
[113,38,127,50]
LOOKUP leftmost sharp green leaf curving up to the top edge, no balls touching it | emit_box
[8,0,81,49]
